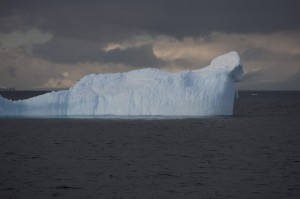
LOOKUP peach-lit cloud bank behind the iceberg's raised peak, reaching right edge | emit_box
[104,31,300,74]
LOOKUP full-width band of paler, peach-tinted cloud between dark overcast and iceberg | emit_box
[0,31,300,89]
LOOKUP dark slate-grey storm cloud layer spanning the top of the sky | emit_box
[1,0,300,40]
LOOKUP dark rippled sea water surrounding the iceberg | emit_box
[0,91,300,199]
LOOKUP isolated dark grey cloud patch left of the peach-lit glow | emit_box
[33,37,164,67]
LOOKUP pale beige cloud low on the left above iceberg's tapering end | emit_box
[0,48,135,89]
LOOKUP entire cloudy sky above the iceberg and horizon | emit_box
[0,0,300,90]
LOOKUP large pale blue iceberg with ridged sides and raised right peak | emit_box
[0,52,243,116]
